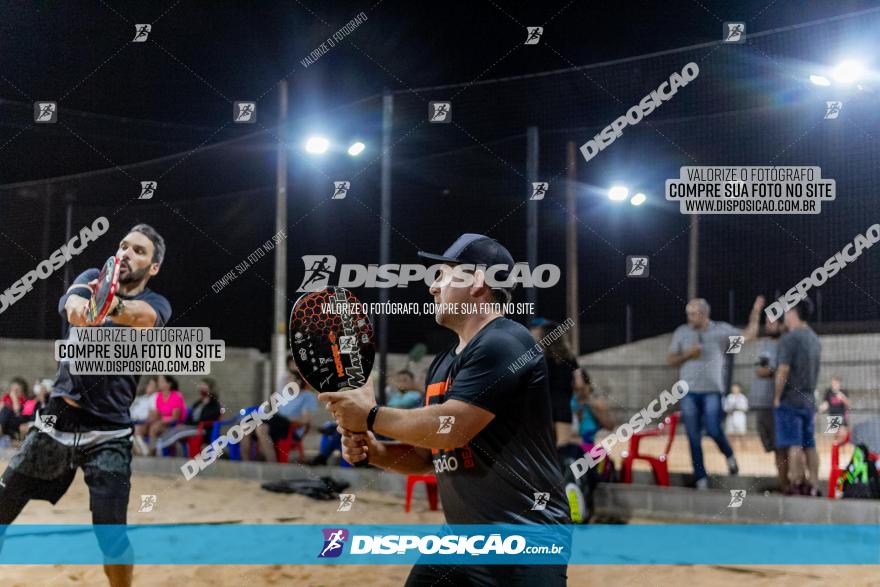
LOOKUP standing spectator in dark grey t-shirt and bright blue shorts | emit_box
[773,298,822,496]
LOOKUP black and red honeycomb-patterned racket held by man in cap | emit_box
[288,286,376,467]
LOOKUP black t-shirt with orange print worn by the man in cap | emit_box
[425,318,570,524]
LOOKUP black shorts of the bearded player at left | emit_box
[0,428,131,524]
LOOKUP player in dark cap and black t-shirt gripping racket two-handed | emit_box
[318,234,570,587]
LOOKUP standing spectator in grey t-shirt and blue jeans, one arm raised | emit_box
[666,296,764,489]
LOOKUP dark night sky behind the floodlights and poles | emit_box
[0,0,880,351]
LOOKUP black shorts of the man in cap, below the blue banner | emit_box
[406,565,568,587]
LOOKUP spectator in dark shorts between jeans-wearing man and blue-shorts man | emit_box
[749,317,788,493]
